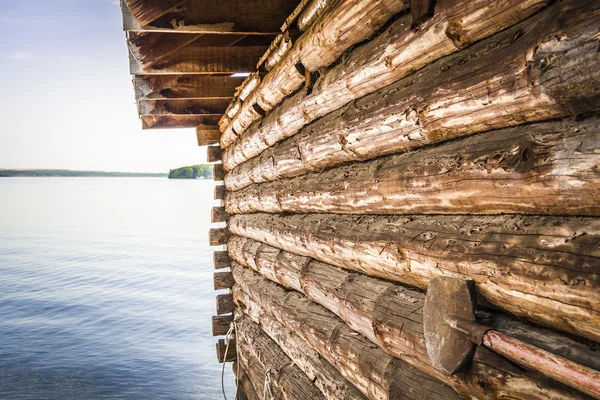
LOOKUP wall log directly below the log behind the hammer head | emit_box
[233,263,460,399]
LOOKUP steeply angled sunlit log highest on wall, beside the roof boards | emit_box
[221,0,404,148]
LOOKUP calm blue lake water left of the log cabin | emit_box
[0,178,233,400]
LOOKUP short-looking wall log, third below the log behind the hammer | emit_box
[237,316,324,399]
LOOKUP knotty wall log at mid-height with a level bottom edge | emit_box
[225,115,600,216]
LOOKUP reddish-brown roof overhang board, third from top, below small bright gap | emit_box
[133,75,244,100]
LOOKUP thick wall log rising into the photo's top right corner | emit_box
[224,2,600,190]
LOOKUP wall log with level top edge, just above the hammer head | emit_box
[229,214,600,341]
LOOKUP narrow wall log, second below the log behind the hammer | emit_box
[232,285,366,400]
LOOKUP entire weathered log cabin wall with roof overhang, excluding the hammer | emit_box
[122,0,600,400]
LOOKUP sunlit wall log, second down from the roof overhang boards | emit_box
[224,0,562,170]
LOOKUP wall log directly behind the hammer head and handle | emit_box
[228,237,600,398]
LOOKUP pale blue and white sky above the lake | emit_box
[0,0,206,172]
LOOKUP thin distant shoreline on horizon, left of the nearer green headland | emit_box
[0,169,168,178]
